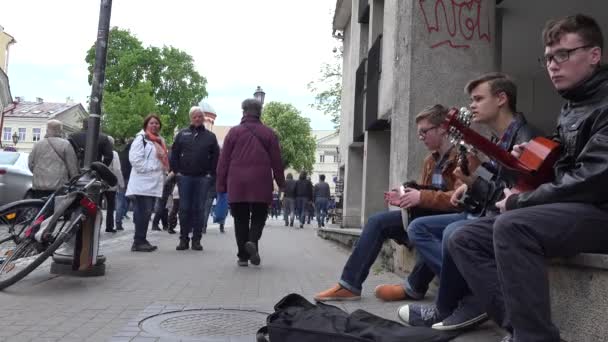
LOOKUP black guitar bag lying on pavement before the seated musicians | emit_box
[256,293,458,342]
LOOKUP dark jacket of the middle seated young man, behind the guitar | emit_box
[467,114,540,216]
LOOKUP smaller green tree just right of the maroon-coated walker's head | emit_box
[262,102,316,172]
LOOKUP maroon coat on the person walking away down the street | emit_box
[216,116,285,204]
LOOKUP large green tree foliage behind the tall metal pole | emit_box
[85,27,207,142]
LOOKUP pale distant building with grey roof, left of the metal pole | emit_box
[0,97,88,152]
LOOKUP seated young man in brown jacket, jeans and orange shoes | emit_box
[315,105,460,301]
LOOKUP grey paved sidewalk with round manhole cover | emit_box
[0,214,500,342]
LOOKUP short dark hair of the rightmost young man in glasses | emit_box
[543,14,604,50]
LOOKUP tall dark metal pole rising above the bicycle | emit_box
[84,0,112,168]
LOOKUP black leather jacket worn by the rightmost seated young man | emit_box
[507,67,608,210]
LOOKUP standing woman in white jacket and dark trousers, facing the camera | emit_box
[126,114,169,252]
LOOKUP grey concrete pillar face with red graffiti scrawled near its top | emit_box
[391,0,496,187]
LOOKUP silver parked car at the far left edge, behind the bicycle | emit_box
[0,151,33,205]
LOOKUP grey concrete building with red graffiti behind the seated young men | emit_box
[333,0,608,227]
